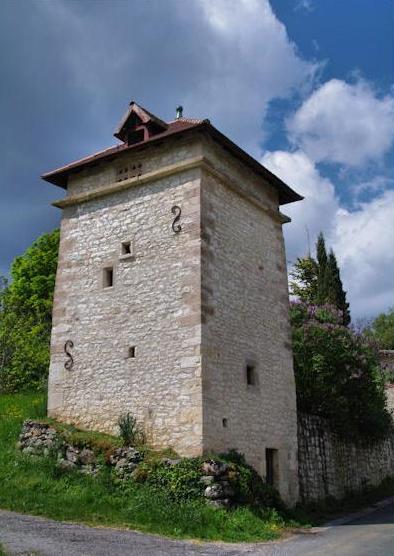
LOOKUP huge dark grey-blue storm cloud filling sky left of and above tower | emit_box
[0,0,314,273]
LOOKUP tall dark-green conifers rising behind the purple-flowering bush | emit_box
[290,232,350,326]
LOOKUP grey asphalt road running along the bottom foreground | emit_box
[0,501,394,556]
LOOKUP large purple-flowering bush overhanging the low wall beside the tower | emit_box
[290,301,391,439]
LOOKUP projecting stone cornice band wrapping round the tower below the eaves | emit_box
[52,156,289,224]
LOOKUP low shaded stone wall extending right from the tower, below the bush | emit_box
[298,415,394,502]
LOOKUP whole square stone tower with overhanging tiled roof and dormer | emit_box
[43,102,301,503]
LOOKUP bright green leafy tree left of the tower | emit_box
[0,230,59,391]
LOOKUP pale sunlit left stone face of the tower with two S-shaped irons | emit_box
[48,137,202,455]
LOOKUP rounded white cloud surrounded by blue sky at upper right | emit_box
[287,79,394,166]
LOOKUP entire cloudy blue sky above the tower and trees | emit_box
[0,0,394,319]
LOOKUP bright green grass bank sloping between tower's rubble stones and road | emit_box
[0,393,285,544]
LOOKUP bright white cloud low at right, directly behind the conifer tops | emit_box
[262,151,394,318]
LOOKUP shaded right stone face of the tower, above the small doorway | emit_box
[201,153,298,504]
